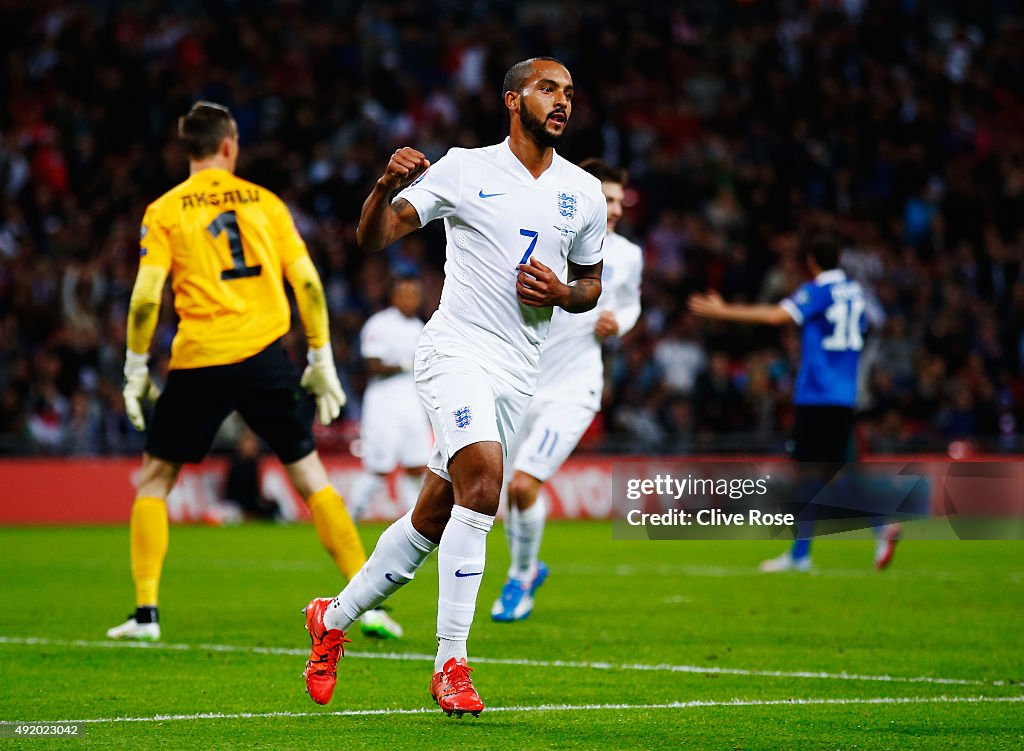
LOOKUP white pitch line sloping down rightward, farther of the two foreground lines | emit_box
[0,636,1011,686]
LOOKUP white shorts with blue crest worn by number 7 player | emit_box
[415,344,529,482]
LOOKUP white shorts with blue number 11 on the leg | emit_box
[512,400,597,483]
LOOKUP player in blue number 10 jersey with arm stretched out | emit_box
[689,236,899,572]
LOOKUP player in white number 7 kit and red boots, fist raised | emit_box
[305,57,606,716]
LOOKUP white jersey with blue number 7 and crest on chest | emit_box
[395,138,607,393]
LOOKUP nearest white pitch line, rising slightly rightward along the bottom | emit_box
[8,696,1024,724]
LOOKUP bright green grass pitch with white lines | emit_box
[0,523,1024,751]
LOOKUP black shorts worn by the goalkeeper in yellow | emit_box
[145,339,316,464]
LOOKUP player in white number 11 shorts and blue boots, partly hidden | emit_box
[490,159,643,622]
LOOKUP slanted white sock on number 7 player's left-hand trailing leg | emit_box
[324,511,437,631]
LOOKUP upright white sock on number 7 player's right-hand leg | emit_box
[434,506,495,672]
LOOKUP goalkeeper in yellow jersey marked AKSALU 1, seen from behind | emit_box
[106,101,401,639]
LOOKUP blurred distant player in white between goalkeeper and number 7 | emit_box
[348,277,431,519]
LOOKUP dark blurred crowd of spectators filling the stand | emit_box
[0,0,1024,456]
